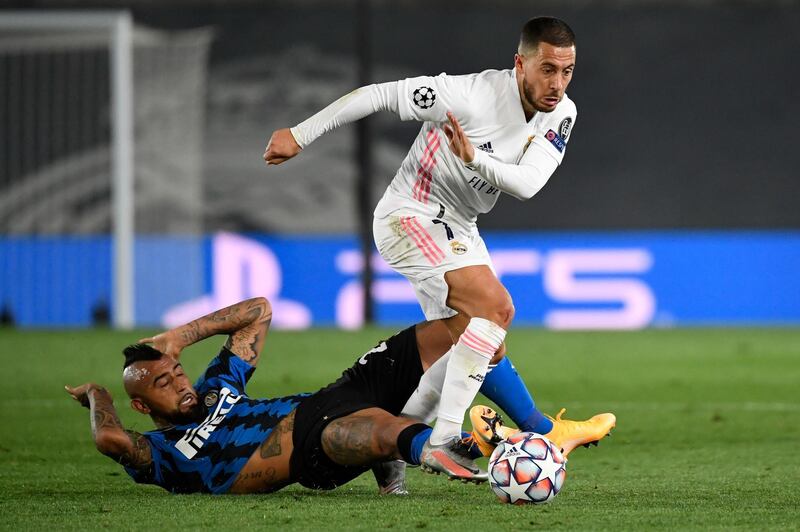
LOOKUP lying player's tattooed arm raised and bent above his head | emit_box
[139,297,272,366]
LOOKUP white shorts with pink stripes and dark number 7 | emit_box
[372,211,494,320]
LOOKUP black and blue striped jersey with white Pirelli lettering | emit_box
[125,347,309,493]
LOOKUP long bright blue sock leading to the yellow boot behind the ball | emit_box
[480,356,553,434]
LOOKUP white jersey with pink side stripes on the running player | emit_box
[375,70,577,225]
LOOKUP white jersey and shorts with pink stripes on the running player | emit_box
[291,70,576,320]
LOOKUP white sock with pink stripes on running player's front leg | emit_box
[431,318,506,445]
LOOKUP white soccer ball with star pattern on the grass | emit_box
[489,432,567,504]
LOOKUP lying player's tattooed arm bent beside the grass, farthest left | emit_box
[64,383,152,469]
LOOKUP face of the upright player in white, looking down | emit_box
[514,42,575,113]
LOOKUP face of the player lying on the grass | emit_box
[129,356,205,424]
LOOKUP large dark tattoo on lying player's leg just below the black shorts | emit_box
[322,416,382,465]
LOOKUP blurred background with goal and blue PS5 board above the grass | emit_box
[0,0,800,329]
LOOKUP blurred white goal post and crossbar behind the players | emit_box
[0,10,134,329]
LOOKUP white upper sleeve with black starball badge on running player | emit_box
[397,73,474,122]
